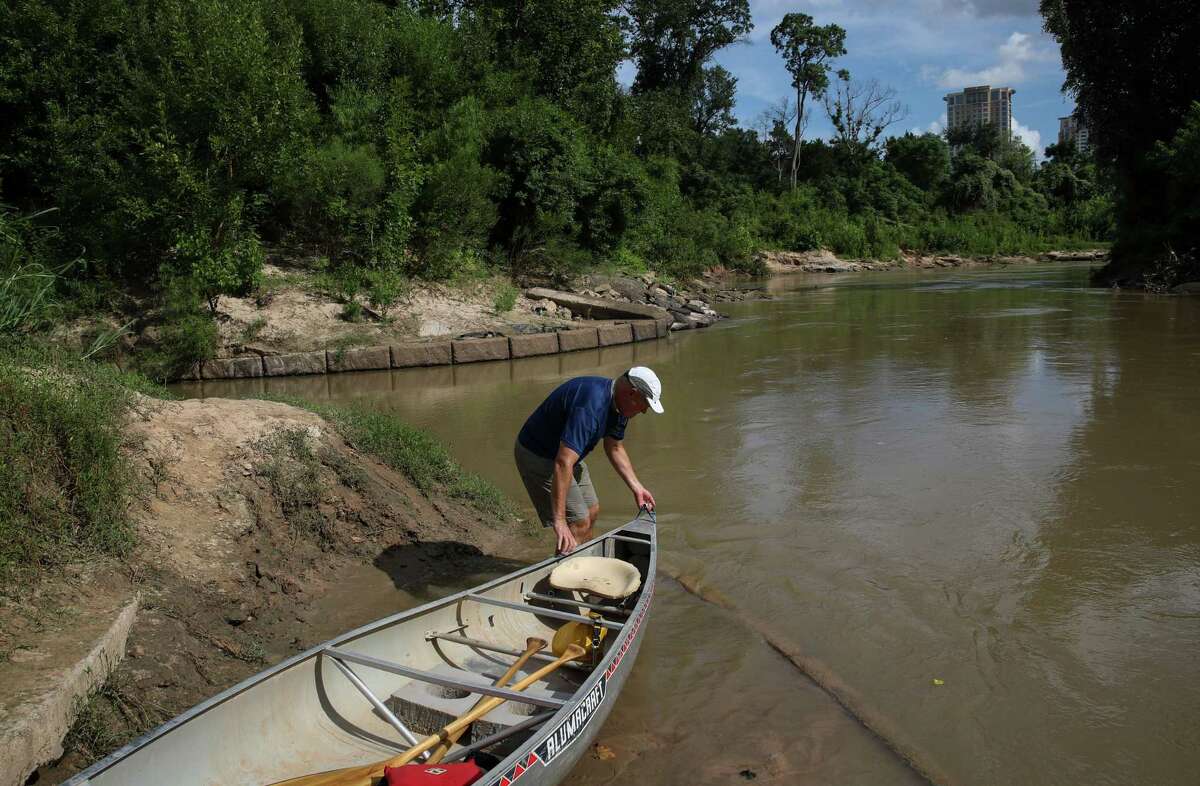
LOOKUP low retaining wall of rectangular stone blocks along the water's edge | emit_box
[187,319,671,379]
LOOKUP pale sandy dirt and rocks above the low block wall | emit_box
[54,260,763,376]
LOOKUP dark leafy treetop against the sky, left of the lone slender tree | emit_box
[625,0,754,92]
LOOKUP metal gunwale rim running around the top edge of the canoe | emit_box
[61,518,658,786]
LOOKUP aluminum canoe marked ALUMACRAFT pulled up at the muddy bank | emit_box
[66,518,656,786]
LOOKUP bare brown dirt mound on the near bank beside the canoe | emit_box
[27,398,527,782]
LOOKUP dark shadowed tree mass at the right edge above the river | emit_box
[1042,0,1200,288]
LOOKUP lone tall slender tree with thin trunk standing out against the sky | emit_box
[770,13,846,188]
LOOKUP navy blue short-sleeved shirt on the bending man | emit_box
[517,377,629,460]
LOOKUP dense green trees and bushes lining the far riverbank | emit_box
[0,0,1106,336]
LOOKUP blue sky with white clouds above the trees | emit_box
[633,0,1074,158]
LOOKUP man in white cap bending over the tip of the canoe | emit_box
[514,366,662,554]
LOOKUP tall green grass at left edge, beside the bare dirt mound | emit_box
[0,340,169,581]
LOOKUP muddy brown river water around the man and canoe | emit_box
[180,266,1200,786]
